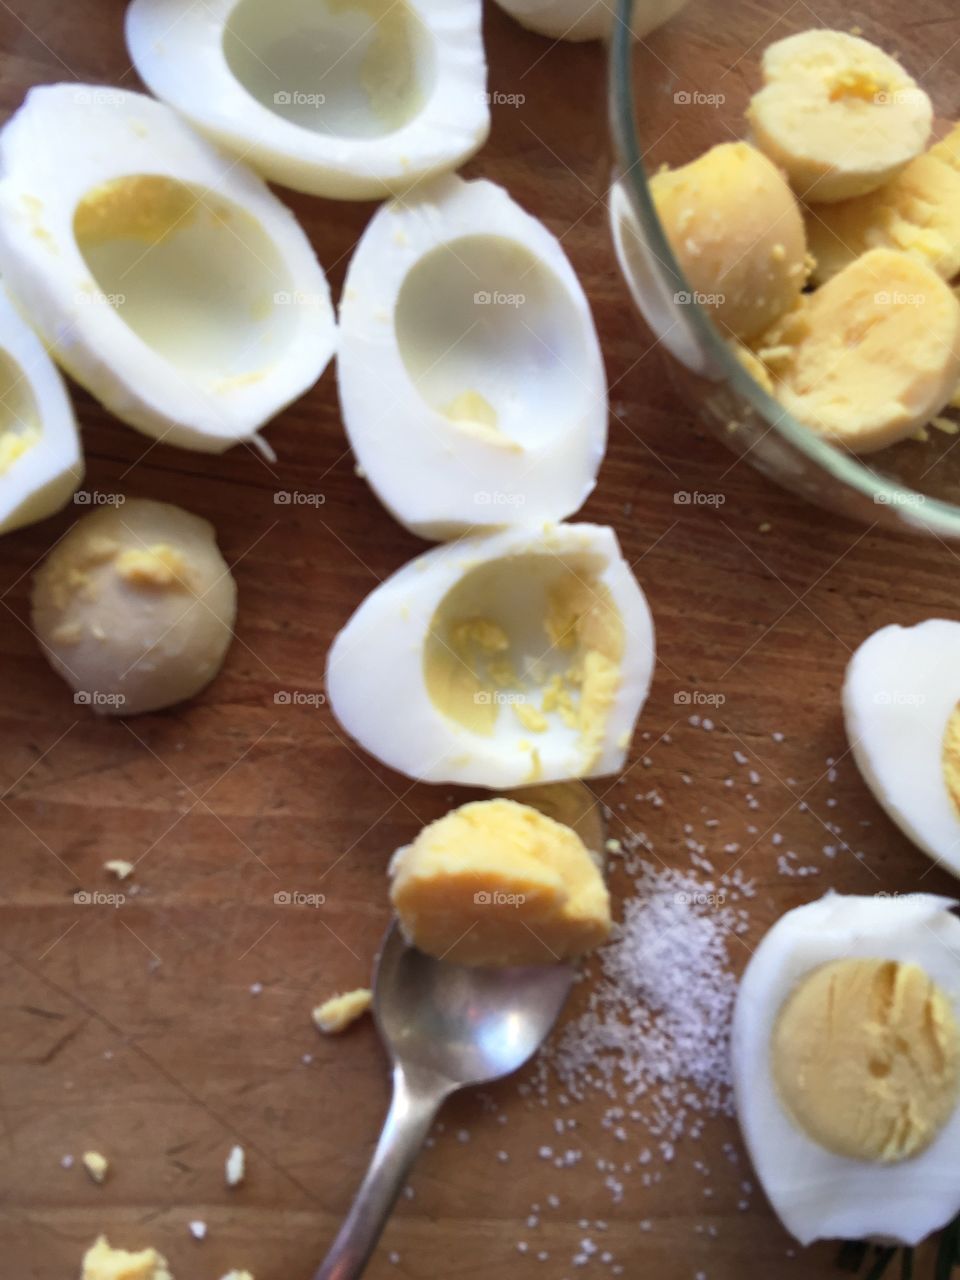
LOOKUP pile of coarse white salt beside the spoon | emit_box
[532,836,754,1172]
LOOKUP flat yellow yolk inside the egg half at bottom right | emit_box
[771,959,960,1164]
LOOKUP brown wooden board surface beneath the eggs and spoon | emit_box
[0,0,960,1280]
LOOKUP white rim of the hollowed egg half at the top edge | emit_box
[127,0,490,200]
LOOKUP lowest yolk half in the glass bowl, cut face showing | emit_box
[754,248,960,453]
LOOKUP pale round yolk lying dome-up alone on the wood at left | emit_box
[32,498,237,716]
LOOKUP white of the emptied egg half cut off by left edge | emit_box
[0,289,83,534]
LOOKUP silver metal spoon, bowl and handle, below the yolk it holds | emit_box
[314,922,573,1280]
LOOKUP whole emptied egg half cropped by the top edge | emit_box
[127,0,490,200]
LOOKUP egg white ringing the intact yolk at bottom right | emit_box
[732,892,960,1244]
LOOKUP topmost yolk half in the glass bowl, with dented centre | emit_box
[746,28,933,204]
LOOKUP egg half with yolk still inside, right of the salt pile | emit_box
[732,893,960,1244]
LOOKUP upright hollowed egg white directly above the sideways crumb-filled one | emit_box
[337,175,607,538]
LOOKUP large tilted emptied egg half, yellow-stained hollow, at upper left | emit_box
[0,84,335,453]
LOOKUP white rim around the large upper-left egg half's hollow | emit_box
[0,84,335,453]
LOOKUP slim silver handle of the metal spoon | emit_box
[314,1064,449,1280]
